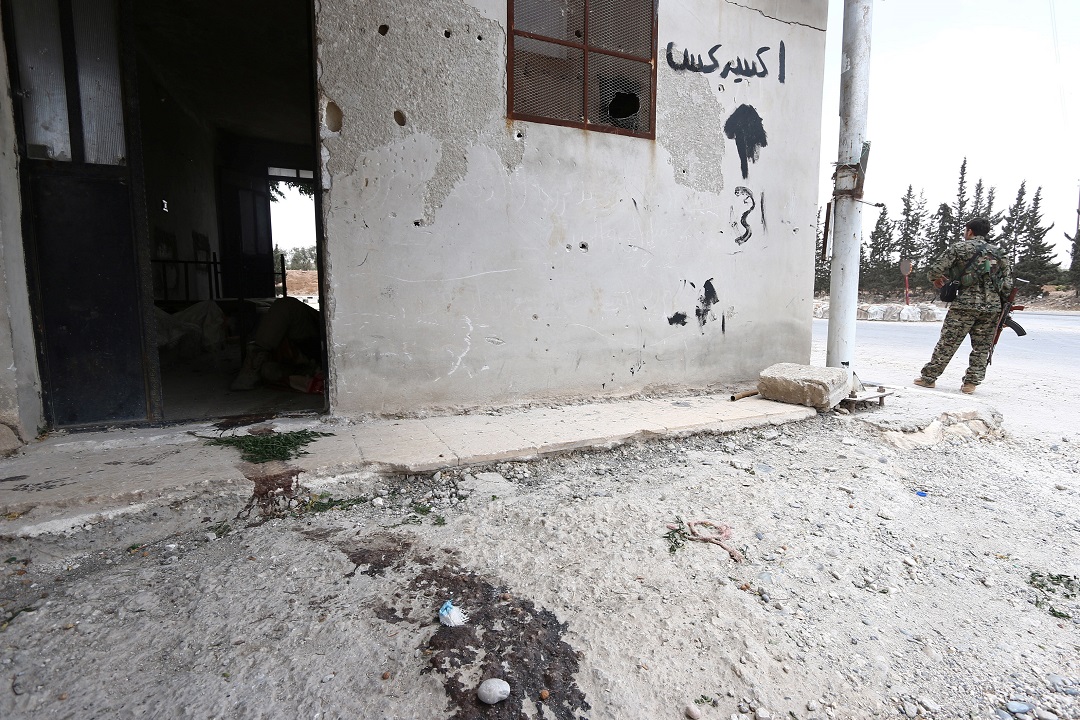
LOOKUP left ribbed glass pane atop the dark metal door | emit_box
[11,0,71,160]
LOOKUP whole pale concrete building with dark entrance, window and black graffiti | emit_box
[0,0,827,440]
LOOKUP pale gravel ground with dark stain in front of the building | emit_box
[0,411,1080,720]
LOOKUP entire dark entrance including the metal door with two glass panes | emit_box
[2,0,326,426]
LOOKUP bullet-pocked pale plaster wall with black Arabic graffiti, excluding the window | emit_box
[316,0,826,415]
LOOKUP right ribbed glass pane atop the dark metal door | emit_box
[71,0,127,165]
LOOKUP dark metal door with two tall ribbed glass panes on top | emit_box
[3,0,160,426]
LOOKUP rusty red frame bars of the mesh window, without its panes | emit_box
[507,0,659,140]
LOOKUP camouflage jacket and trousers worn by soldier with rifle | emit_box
[921,235,1012,385]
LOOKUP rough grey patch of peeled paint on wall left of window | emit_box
[316,0,524,226]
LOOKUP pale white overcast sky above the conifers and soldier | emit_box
[820,0,1080,268]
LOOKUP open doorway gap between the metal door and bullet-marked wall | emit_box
[130,0,325,421]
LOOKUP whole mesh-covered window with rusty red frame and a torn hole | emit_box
[507,0,657,138]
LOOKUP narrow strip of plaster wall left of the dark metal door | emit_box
[0,19,43,446]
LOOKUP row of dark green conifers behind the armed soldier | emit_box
[814,158,1080,294]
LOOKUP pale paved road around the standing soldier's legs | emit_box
[811,312,1080,439]
